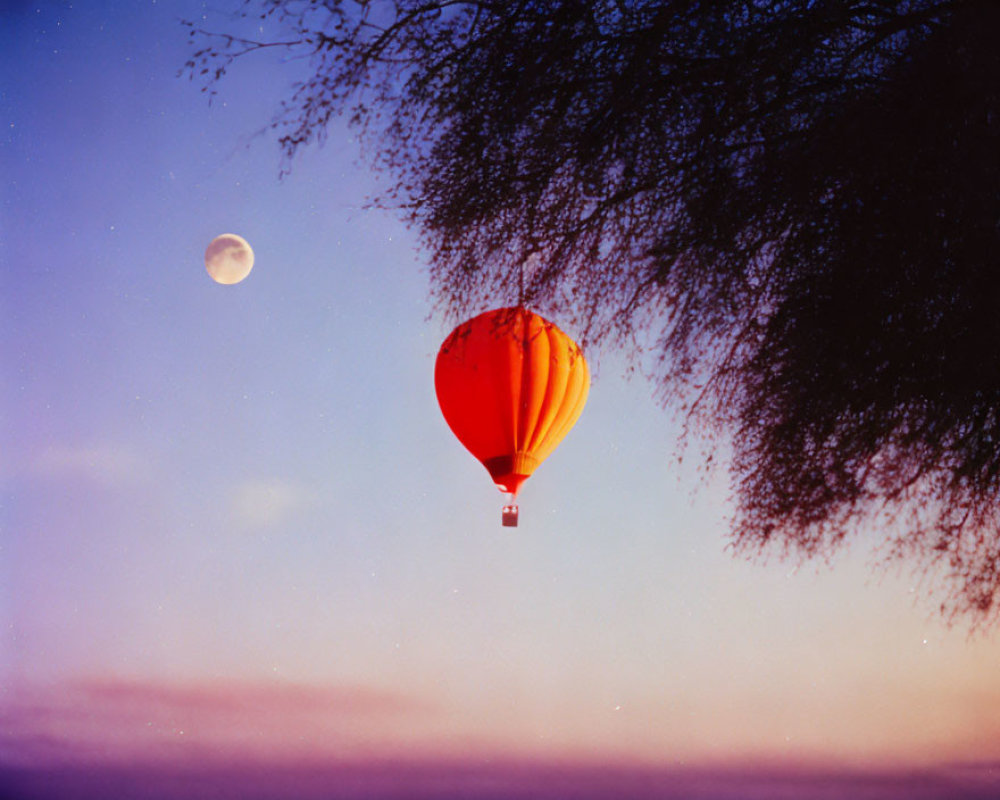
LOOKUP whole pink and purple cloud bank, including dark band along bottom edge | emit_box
[0,678,1000,800]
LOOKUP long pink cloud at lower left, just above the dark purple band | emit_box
[0,678,437,768]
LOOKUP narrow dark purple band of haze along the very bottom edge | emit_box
[0,762,1000,800]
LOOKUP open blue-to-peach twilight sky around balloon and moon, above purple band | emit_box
[0,0,1000,796]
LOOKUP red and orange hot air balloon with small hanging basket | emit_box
[434,306,590,527]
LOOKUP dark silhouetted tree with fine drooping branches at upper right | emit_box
[187,0,1000,622]
